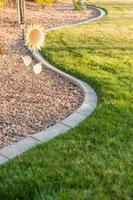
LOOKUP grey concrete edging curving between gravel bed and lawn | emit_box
[0,6,106,165]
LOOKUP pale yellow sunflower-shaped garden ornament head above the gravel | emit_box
[25,24,45,50]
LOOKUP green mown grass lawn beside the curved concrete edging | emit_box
[0,0,133,200]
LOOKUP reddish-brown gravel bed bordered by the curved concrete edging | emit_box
[0,2,99,148]
